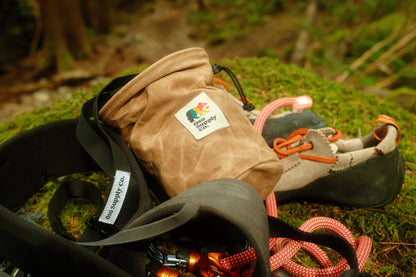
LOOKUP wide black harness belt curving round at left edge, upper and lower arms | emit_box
[0,120,129,277]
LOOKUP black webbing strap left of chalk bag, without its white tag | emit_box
[77,75,152,235]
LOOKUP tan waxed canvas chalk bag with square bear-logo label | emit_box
[99,48,282,199]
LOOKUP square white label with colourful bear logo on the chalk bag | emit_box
[175,92,230,140]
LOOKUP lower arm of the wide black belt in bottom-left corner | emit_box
[0,205,129,277]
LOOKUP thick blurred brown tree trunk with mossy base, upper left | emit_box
[38,0,93,72]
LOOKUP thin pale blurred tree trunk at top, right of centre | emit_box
[291,0,318,67]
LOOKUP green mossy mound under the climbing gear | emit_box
[0,58,416,276]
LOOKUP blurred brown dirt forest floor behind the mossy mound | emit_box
[0,0,303,122]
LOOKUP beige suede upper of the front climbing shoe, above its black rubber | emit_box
[274,116,399,192]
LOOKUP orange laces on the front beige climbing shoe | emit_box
[273,129,342,163]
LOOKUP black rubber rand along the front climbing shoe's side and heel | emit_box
[276,148,405,208]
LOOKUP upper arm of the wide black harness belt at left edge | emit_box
[0,119,101,212]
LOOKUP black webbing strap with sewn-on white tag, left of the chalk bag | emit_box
[77,75,152,235]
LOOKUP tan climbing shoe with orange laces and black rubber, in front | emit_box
[273,115,404,208]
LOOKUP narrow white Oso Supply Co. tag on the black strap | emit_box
[98,170,130,224]
